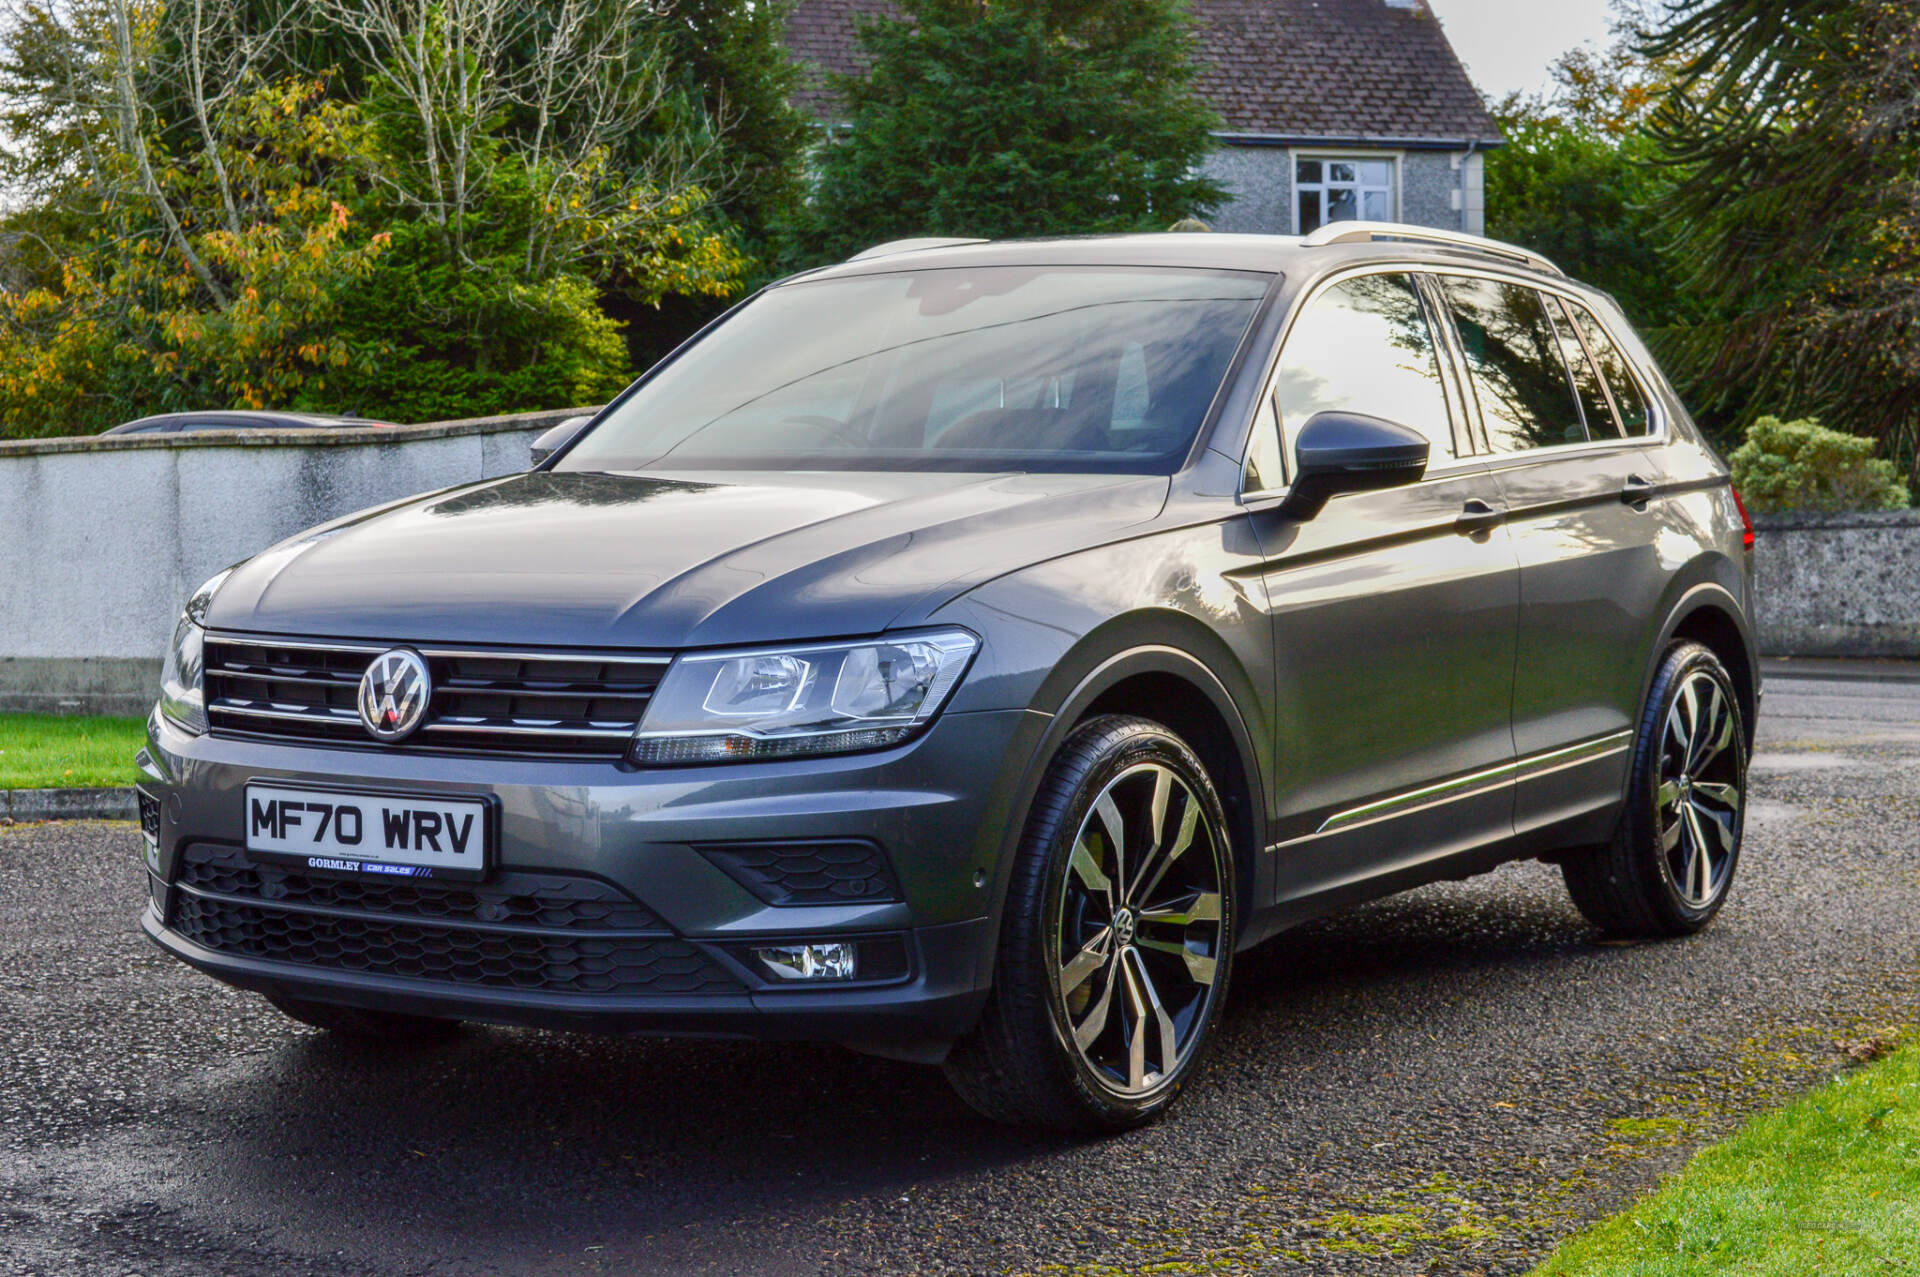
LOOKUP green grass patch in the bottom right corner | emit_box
[1534,1047,1920,1277]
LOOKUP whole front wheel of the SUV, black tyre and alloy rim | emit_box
[947,716,1235,1131]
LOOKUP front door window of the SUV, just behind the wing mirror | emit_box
[1275,275,1453,461]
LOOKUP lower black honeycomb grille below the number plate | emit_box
[169,847,741,997]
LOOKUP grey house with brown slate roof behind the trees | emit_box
[787,0,1500,234]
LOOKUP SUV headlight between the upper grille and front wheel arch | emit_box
[634,630,979,764]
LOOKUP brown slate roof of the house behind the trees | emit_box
[787,0,1500,142]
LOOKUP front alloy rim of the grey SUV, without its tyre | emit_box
[1054,762,1225,1096]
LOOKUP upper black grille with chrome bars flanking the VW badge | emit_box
[205,634,668,759]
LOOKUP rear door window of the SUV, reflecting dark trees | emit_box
[1438,275,1586,453]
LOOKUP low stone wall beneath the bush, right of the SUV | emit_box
[1753,511,1920,659]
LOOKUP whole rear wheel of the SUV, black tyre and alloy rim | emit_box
[1561,643,1747,935]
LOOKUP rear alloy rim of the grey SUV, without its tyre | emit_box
[1653,670,1745,910]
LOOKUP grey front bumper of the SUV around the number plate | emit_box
[140,711,1044,1058]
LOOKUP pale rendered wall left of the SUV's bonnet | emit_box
[0,409,593,714]
